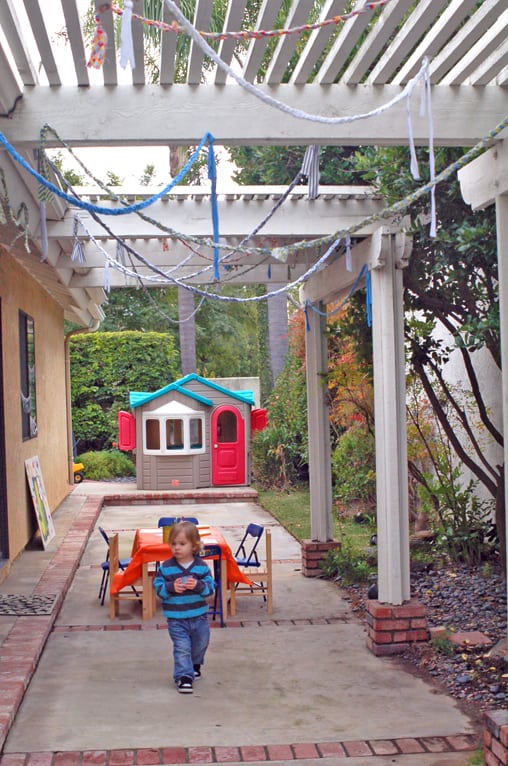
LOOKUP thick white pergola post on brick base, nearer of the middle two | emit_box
[371,236,410,605]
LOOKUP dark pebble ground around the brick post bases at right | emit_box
[346,563,508,719]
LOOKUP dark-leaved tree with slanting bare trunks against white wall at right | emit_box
[356,142,505,564]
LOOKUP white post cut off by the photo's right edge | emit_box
[496,194,508,637]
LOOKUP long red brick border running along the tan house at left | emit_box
[0,496,103,753]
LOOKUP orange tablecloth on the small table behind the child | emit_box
[111,525,251,593]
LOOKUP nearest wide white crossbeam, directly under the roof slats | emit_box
[2,84,506,148]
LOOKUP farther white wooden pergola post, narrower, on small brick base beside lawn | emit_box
[305,302,333,542]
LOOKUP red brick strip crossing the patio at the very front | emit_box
[0,734,478,766]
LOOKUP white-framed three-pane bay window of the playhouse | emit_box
[143,413,205,455]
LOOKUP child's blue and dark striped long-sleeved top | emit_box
[153,556,215,620]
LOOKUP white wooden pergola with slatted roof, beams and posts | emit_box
[0,0,508,604]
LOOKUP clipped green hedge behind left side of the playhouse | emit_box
[70,331,180,453]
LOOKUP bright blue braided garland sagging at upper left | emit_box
[0,132,214,216]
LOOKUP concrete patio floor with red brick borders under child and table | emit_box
[0,481,479,766]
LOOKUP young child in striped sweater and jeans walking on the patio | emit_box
[153,521,214,694]
